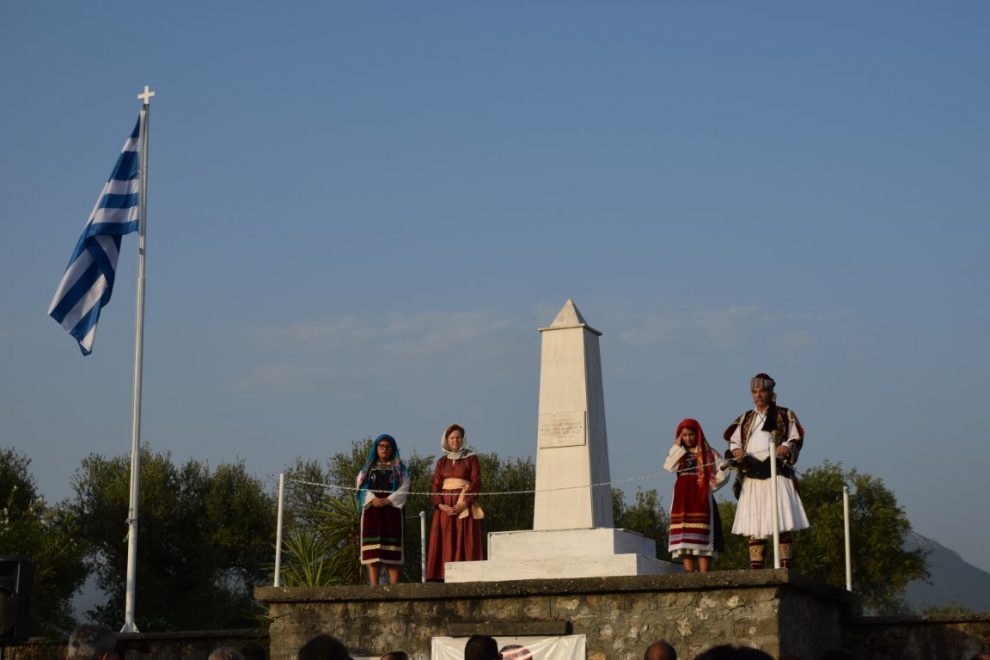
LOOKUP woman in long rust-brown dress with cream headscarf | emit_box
[426,424,484,582]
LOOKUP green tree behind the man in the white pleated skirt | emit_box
[719,461,929,614]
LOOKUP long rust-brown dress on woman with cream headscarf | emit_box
[426,455,484,582]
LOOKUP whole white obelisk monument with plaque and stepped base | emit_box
[445,300,678,582]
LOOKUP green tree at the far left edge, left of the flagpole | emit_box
[0,449,88,637]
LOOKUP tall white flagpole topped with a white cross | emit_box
[120,85,155,633]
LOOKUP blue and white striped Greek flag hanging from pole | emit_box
[48,118,141,355]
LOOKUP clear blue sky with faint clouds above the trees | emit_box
[0,0,990,570]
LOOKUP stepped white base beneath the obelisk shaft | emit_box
[444,527,681,583]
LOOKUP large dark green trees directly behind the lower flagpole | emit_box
[73,446,275,632]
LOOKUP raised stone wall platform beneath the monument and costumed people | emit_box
[255,570,855,660]
